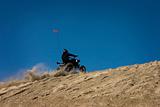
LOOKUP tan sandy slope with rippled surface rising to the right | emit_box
[0,61,160,107]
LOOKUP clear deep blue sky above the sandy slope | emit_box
[0,0,160,79]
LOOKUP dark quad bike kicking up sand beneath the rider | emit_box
[57,58,86,73]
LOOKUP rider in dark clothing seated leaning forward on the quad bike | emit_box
[62,49,77,64]
